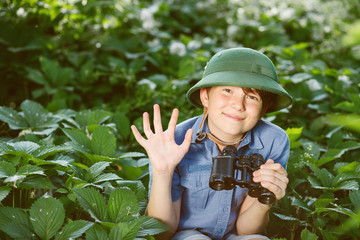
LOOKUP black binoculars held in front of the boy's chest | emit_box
[209,145,276,204]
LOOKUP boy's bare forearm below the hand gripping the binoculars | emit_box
[236,199,271,235]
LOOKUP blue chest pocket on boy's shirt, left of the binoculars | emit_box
[181,167,210,210]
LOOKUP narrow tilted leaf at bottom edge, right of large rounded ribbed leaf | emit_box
[55,220,94,240]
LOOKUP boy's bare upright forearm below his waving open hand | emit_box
[147,173,179,232]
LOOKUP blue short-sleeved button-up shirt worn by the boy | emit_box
[149,116,289,239]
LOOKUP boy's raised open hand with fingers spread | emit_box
[131,104,192,174]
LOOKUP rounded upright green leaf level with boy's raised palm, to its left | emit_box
[91,126,116,157]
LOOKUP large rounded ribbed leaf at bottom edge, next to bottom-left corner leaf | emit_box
[29,198,65,239]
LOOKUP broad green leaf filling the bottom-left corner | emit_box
[0,207,33,239]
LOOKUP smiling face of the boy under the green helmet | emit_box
[200,86,263,142]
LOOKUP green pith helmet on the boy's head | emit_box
[187,48,292,112]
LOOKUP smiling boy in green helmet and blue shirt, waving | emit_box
[131,48,292,240]
